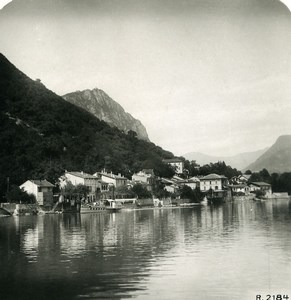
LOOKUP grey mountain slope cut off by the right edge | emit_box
[245,135,291,173]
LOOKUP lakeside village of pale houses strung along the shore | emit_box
[1,158,282,215]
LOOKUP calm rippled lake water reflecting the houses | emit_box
[0,200,291,300]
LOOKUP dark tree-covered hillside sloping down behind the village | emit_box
[0,54,173,197]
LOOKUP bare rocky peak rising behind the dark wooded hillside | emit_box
[63,89,149,141]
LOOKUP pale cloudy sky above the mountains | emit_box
[0,0,291,156]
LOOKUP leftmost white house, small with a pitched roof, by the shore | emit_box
[19,180,54,207]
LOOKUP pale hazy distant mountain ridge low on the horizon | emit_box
[183,148,268,170]
